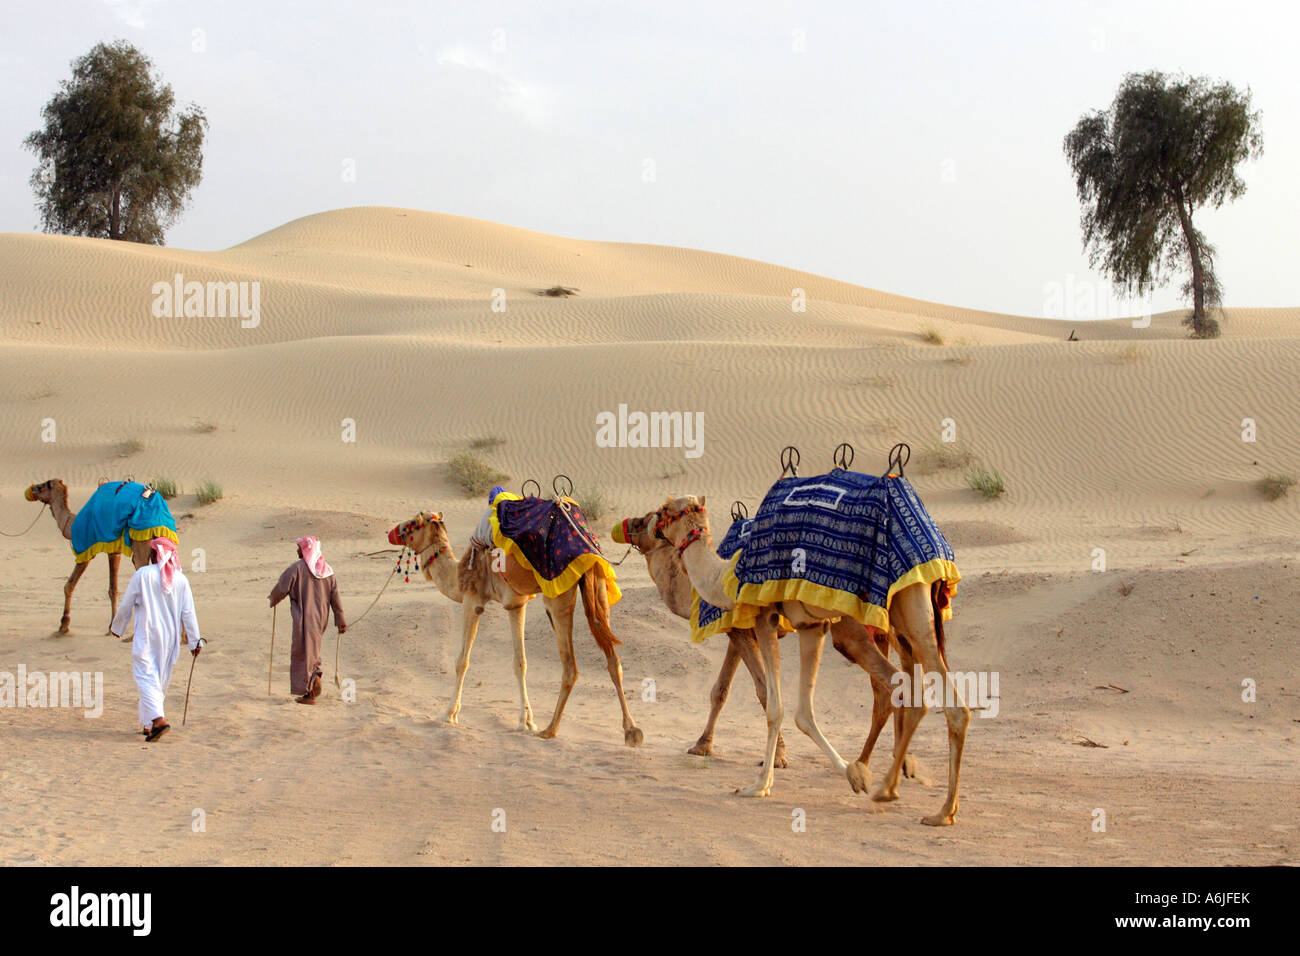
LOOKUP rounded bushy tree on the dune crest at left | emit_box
[23,40,208,246]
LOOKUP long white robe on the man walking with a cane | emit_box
[112,564,203,727]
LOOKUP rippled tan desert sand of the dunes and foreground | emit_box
[0,208,1300,865]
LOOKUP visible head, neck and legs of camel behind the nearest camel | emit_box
[615,511,919,778]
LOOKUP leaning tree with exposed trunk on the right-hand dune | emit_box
[1065,73,1264,338]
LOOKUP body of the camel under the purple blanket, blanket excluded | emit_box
[389,511,644,747]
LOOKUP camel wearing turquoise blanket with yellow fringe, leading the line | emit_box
[23,479,181,640]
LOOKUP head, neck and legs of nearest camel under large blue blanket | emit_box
[654,496,970,826]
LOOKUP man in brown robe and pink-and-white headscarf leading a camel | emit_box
[270,536,347,704]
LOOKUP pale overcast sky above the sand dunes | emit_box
[0,0,1300,315]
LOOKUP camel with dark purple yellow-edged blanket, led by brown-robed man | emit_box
[389,489,644,747]
